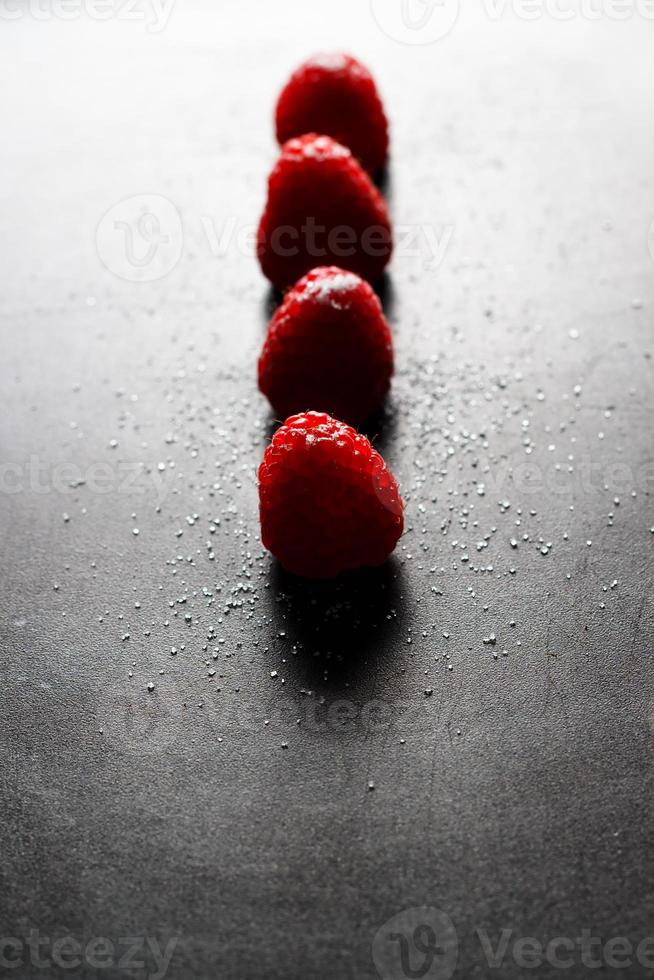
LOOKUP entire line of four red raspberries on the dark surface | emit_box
[257,54,404,578]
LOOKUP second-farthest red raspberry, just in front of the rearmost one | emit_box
[257,133,393,289]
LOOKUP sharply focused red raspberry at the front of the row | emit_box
[259,412,404,578]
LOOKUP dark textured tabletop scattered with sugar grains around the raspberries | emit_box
[0,7,654,980]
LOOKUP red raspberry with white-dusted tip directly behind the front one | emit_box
[259,266,393,425]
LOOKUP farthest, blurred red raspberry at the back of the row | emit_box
[275,54,388,174]
